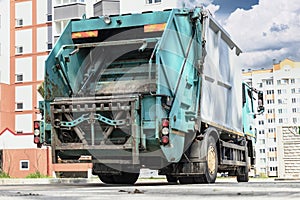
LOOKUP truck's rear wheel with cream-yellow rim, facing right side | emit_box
[199,135,218,183]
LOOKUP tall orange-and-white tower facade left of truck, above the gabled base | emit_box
[0,0,52,134]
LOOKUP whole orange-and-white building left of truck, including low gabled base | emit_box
[0,0,52,177]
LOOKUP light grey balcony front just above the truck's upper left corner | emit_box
[54,3,85,21]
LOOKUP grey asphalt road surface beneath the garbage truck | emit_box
[0,179,300,200]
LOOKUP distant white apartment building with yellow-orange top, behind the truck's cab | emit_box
[244,59,300,176]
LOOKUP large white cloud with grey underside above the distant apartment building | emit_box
[221,0,300,68]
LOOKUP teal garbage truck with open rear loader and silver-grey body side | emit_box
[34,7,263,184]
